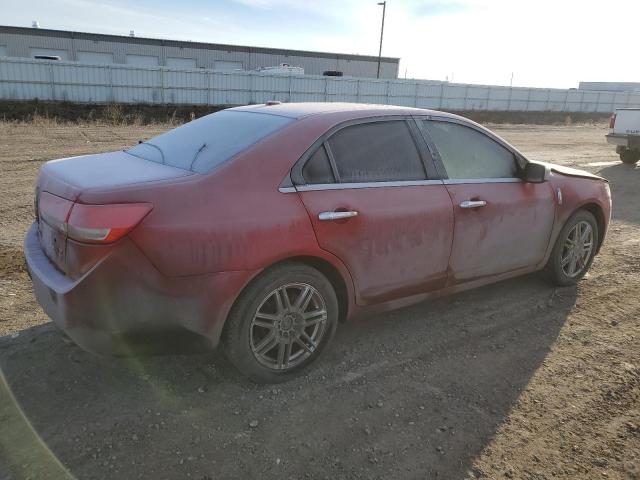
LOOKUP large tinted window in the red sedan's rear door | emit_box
[328,120,426,183]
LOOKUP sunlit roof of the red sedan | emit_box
[230,102,457,119]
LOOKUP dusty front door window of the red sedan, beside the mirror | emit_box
[424,120,518,179]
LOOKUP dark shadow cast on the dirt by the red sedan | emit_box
[0,275,576,479]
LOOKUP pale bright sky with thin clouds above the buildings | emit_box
[0,0,640,88]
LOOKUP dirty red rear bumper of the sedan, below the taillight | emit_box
[24,224,255,355]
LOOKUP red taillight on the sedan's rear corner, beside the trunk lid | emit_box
[67,203,153,243]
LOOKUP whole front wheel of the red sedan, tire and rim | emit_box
[545,210,599,286]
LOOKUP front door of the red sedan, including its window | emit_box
[418,119,555,284]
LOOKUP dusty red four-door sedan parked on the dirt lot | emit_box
[25,102,611,382]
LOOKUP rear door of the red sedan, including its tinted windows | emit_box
[292,117,453,304]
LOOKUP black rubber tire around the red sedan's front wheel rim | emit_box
[544,210,600,286]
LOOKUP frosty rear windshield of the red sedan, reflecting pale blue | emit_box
[126,110,292,173]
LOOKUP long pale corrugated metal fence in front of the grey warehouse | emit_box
[0,58,640,112]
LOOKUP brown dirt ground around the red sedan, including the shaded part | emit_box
[0,122,640,480]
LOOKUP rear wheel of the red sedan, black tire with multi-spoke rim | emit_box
[222,262,338,383]
